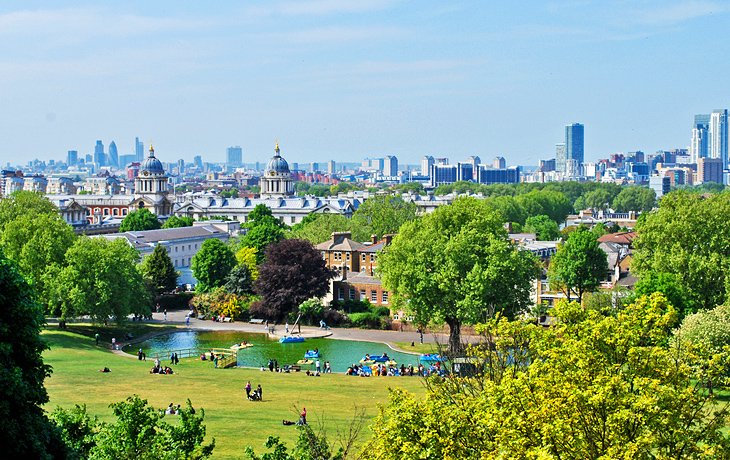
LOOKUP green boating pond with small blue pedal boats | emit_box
[136,331,419,372]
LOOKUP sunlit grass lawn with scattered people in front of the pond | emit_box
[42,326,424,458]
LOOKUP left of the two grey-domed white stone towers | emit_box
[130,146,173,216]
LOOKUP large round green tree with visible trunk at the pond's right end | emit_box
[378,198,538,353]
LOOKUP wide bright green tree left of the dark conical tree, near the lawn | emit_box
[46,237,150,323]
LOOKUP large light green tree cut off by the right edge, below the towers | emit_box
[631,190,730,312]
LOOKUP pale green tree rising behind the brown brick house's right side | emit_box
[348,195,416,241]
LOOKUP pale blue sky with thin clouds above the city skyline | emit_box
[0,0,730,165]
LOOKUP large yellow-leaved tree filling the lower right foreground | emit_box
[362,294,730,460]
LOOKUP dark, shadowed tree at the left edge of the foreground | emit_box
[0,251,61,459]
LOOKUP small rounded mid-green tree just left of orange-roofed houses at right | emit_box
[548,227,608,303]
